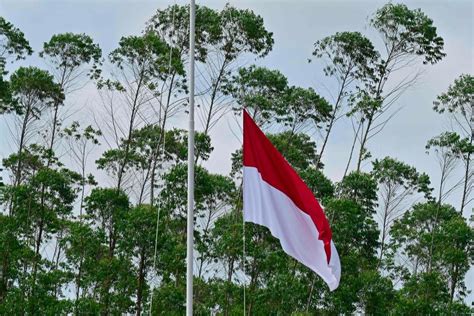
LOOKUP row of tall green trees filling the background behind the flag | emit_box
[0,3,474,315]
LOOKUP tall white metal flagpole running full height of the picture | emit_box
[186,0,196,316]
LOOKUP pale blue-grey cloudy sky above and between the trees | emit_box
[0,0,474,302]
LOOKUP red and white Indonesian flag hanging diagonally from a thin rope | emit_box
[243,110,341,291]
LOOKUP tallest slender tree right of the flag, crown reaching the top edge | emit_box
[355,3,446,170]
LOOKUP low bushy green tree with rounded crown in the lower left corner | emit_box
[3,167,79,313]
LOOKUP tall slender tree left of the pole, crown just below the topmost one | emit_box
[98,32,184,189]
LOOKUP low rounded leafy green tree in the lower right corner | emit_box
[390,202,474,303]
